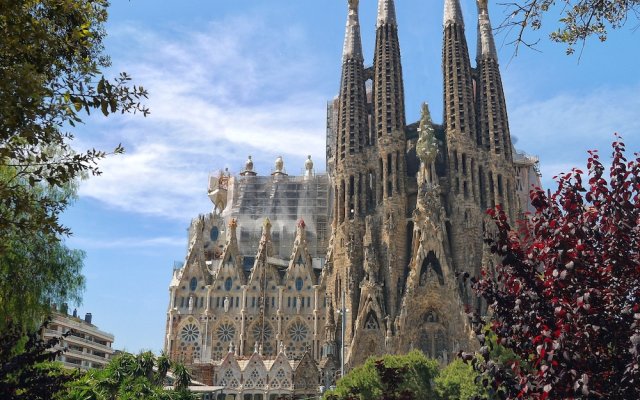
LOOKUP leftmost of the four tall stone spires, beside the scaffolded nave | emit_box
[326,0,373,372]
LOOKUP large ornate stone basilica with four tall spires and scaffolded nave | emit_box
[165,0,540,399]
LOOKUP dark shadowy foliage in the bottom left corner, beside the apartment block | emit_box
[0,318,76,400]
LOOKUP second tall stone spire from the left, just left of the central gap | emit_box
[370,0,407,318]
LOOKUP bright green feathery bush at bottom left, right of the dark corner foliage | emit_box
[63,352,194,400]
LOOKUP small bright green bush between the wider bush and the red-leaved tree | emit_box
[434,359,485,400]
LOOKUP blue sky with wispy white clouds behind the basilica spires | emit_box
[64,0,640,352]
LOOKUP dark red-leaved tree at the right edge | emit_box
[466,137,640,399]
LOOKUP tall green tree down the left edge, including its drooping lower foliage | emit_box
[0,0,148,332]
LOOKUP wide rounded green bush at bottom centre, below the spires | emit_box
[324,350,438,400]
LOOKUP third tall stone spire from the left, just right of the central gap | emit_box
[442,0,485,302]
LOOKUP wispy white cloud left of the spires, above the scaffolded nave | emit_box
[80,17,326,220]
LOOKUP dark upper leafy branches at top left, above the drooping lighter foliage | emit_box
[0,0,148,241]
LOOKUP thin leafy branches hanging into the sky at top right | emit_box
[500,0,640,54]
